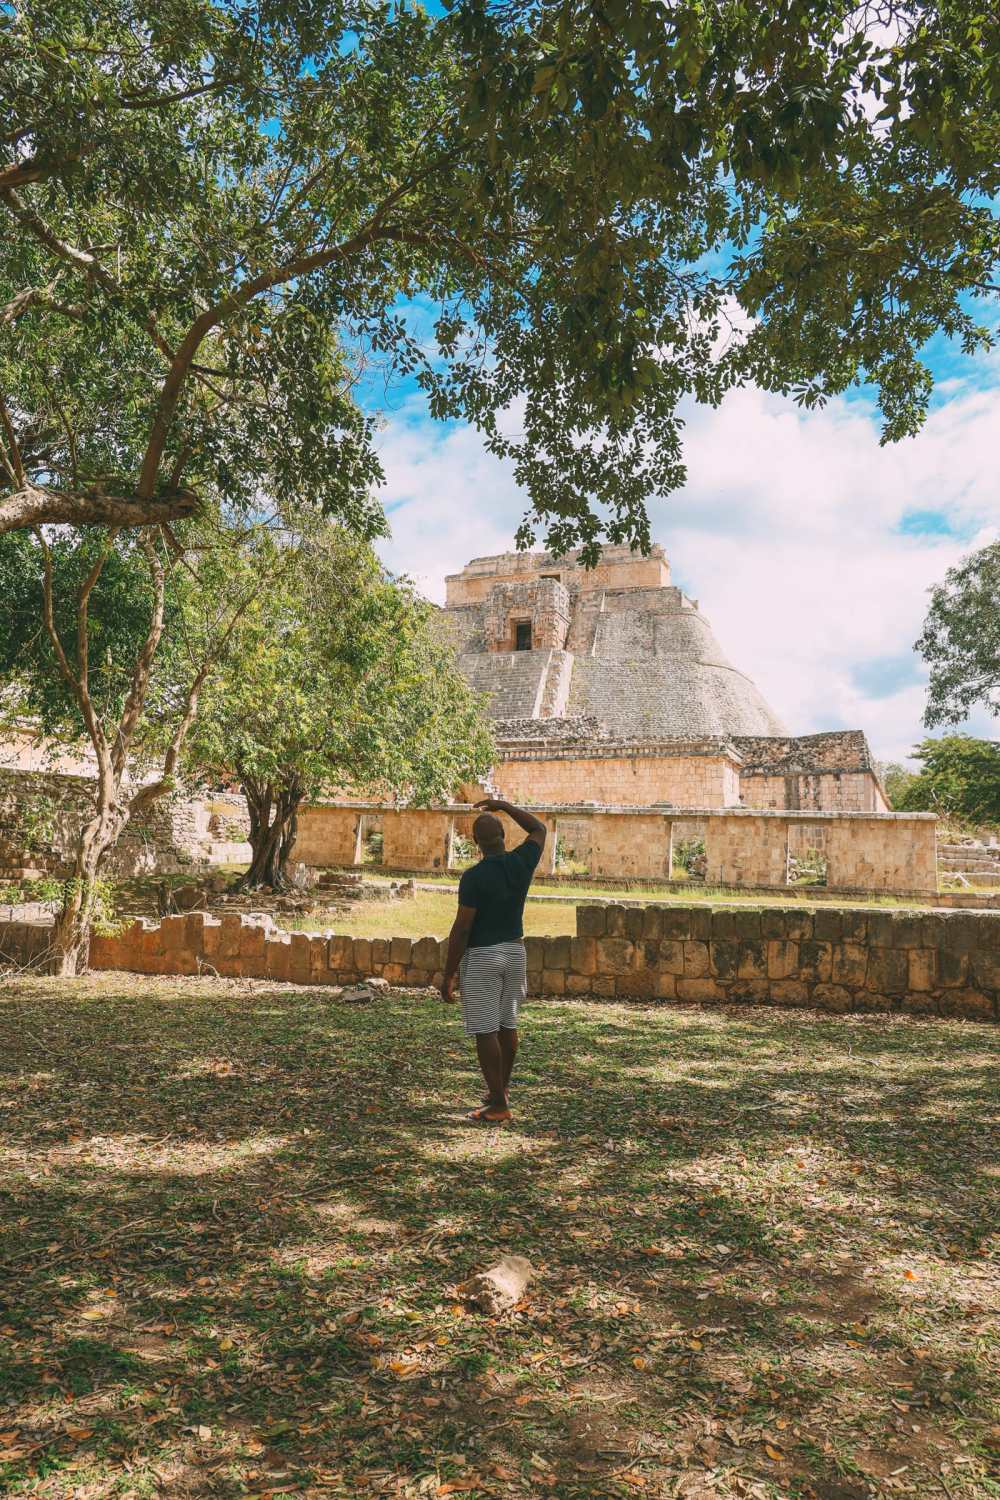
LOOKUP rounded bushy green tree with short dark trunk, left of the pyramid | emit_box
[181,527,493,888]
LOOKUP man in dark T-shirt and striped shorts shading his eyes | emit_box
[441,797,546,1125]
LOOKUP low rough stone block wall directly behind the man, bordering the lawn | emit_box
[82,905,1000,1020]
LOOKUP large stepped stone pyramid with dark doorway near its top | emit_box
[445,546,886,813]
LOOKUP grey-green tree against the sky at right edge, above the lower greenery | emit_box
[915,542,1000,729]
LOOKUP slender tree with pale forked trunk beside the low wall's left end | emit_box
[0,513,275,974]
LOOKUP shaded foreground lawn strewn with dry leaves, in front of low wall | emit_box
[0,975,1000,1500]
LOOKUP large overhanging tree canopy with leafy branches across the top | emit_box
[0,0,1000,557]
